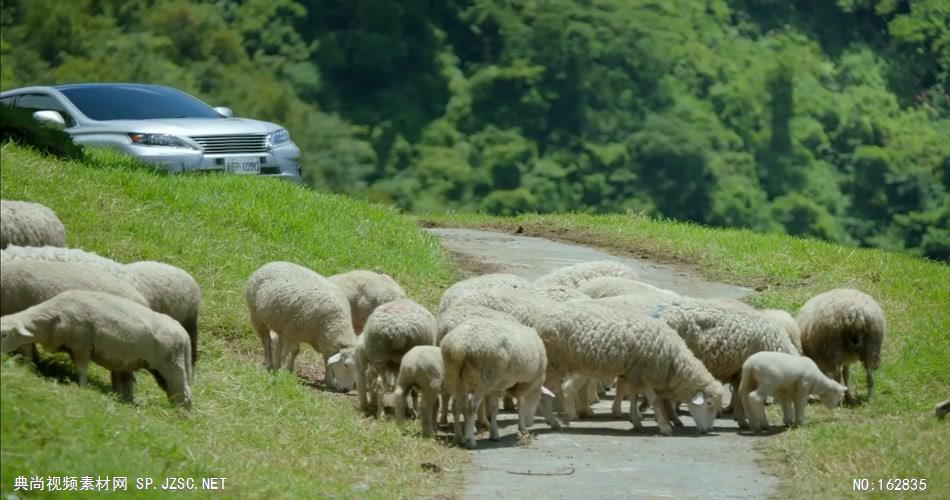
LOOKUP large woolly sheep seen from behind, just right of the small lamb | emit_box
[440,318,560,448]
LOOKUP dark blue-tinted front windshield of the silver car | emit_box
[59,85,221,121]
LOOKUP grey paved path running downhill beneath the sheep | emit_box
[429,228,778,499]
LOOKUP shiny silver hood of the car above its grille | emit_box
[74,118,281,136]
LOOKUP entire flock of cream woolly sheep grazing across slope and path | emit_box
[0,201,885,447]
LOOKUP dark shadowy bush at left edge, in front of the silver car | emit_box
[0,105,83,160]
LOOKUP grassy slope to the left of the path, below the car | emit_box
[0,145,465,498]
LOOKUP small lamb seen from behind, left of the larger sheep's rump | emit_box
[396,345,445,437]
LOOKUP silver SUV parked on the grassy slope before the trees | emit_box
[0,83,301,182]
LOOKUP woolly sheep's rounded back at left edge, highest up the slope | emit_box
[0,200,66,248]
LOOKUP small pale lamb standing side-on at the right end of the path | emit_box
[737,352,848,432]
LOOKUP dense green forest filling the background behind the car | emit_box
[0,0,950,260]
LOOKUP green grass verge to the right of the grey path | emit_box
[426,215,950,497]
